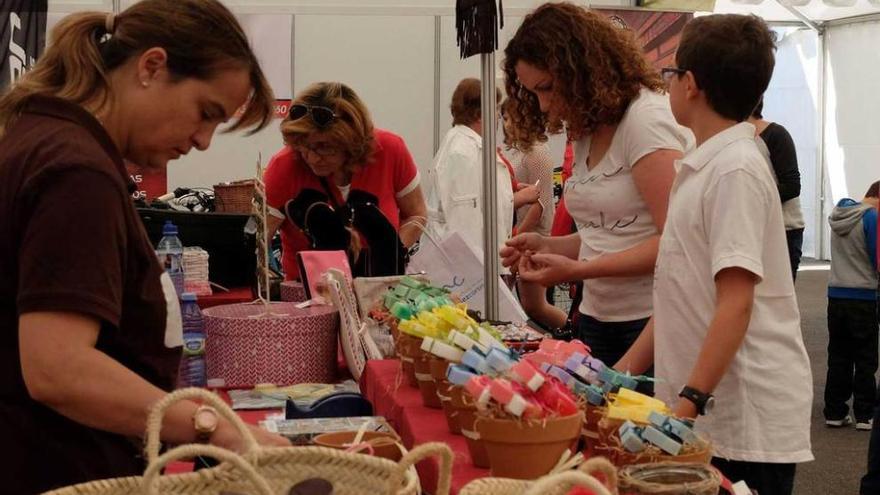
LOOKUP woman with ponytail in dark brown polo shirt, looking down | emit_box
[0,0,287,494]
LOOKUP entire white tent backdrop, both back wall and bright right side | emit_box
[49,0,880,258]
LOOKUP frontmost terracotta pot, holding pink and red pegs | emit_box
[475,412,584,479]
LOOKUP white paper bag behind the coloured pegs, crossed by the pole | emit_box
[407,232,527,323]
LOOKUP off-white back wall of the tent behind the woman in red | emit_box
[49,0,631,194]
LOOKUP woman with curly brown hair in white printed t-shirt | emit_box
[502,3,686,364]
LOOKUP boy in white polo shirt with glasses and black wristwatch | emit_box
[615,15,813,495]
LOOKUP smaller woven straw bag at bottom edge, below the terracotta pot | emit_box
[458,457,617,495]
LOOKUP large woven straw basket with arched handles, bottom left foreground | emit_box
[48,388,452,495]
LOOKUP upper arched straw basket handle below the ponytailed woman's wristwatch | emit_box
[146,387,259,464]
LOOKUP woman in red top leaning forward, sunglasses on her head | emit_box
[264,82,427,280]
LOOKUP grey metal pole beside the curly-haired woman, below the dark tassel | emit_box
[480,52,498,320]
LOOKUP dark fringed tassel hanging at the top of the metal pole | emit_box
[455,0,504,58]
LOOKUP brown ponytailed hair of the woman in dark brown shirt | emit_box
[0,0,275,135]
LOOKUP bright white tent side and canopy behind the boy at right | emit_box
[714,0,880,258]
